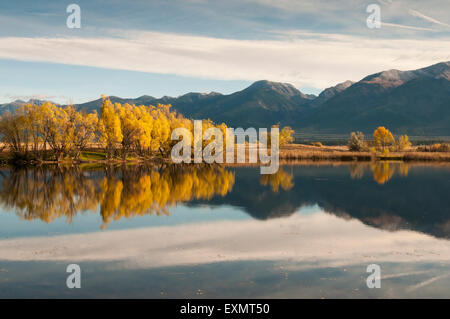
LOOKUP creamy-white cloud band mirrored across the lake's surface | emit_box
[0,213,450,270]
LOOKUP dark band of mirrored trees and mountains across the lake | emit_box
[0,162,450,238]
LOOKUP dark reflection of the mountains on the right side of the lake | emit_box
[191,163,450,238]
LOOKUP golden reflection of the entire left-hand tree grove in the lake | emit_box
[0,167,234,229]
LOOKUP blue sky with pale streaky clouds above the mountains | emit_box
[0,0,450,103]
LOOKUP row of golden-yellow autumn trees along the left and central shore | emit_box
[0,97,294,161]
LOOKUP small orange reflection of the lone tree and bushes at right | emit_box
[350,162,409,184]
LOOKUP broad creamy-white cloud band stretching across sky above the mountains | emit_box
[0,30,450,88]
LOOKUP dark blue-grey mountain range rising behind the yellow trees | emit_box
[0,61,450,136]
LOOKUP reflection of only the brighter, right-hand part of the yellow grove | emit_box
[100,167,234,228]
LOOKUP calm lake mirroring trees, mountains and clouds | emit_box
[0,163,450,298]
